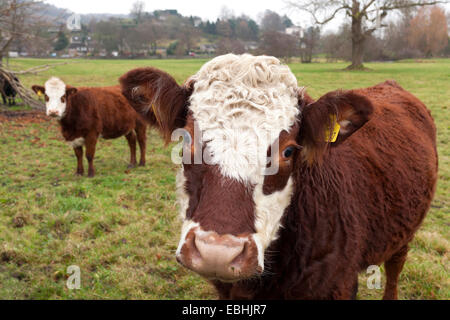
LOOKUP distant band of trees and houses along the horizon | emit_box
[0,0,450,68]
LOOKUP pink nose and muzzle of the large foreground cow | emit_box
[177,228,262,281]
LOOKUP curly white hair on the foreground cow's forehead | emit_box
[190,54,299,183]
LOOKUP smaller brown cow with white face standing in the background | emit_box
[32,77,147,177]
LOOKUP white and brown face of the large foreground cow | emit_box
[177,55,299,280]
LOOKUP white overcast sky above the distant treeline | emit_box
[45,0,339,29]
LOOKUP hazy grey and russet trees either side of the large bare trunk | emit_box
[318,6,450,61]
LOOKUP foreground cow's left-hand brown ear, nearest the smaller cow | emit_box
[119,67,194,143]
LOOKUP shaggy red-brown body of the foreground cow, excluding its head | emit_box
[214,82,438,299]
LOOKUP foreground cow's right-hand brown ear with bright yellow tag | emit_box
[299,91,373,164]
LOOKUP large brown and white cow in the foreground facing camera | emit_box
[121,55,438,299]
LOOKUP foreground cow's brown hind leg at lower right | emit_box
[383,245,408,300]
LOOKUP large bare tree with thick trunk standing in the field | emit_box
[285,0,449,69]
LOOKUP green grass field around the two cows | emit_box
[0,59,450,299]
